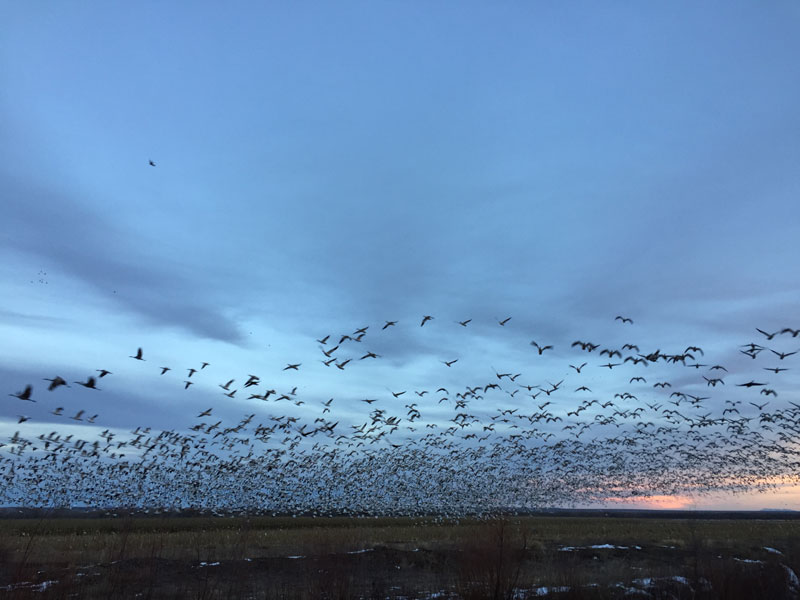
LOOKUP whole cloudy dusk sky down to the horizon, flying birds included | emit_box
[0,0,800,514]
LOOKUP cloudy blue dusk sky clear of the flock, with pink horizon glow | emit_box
[0,1,800,509]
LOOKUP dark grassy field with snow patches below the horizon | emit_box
[0,513,800,599]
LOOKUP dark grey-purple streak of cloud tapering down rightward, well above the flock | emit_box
[0,172,243,343]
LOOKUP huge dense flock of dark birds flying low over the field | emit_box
[0,315,800,515]
